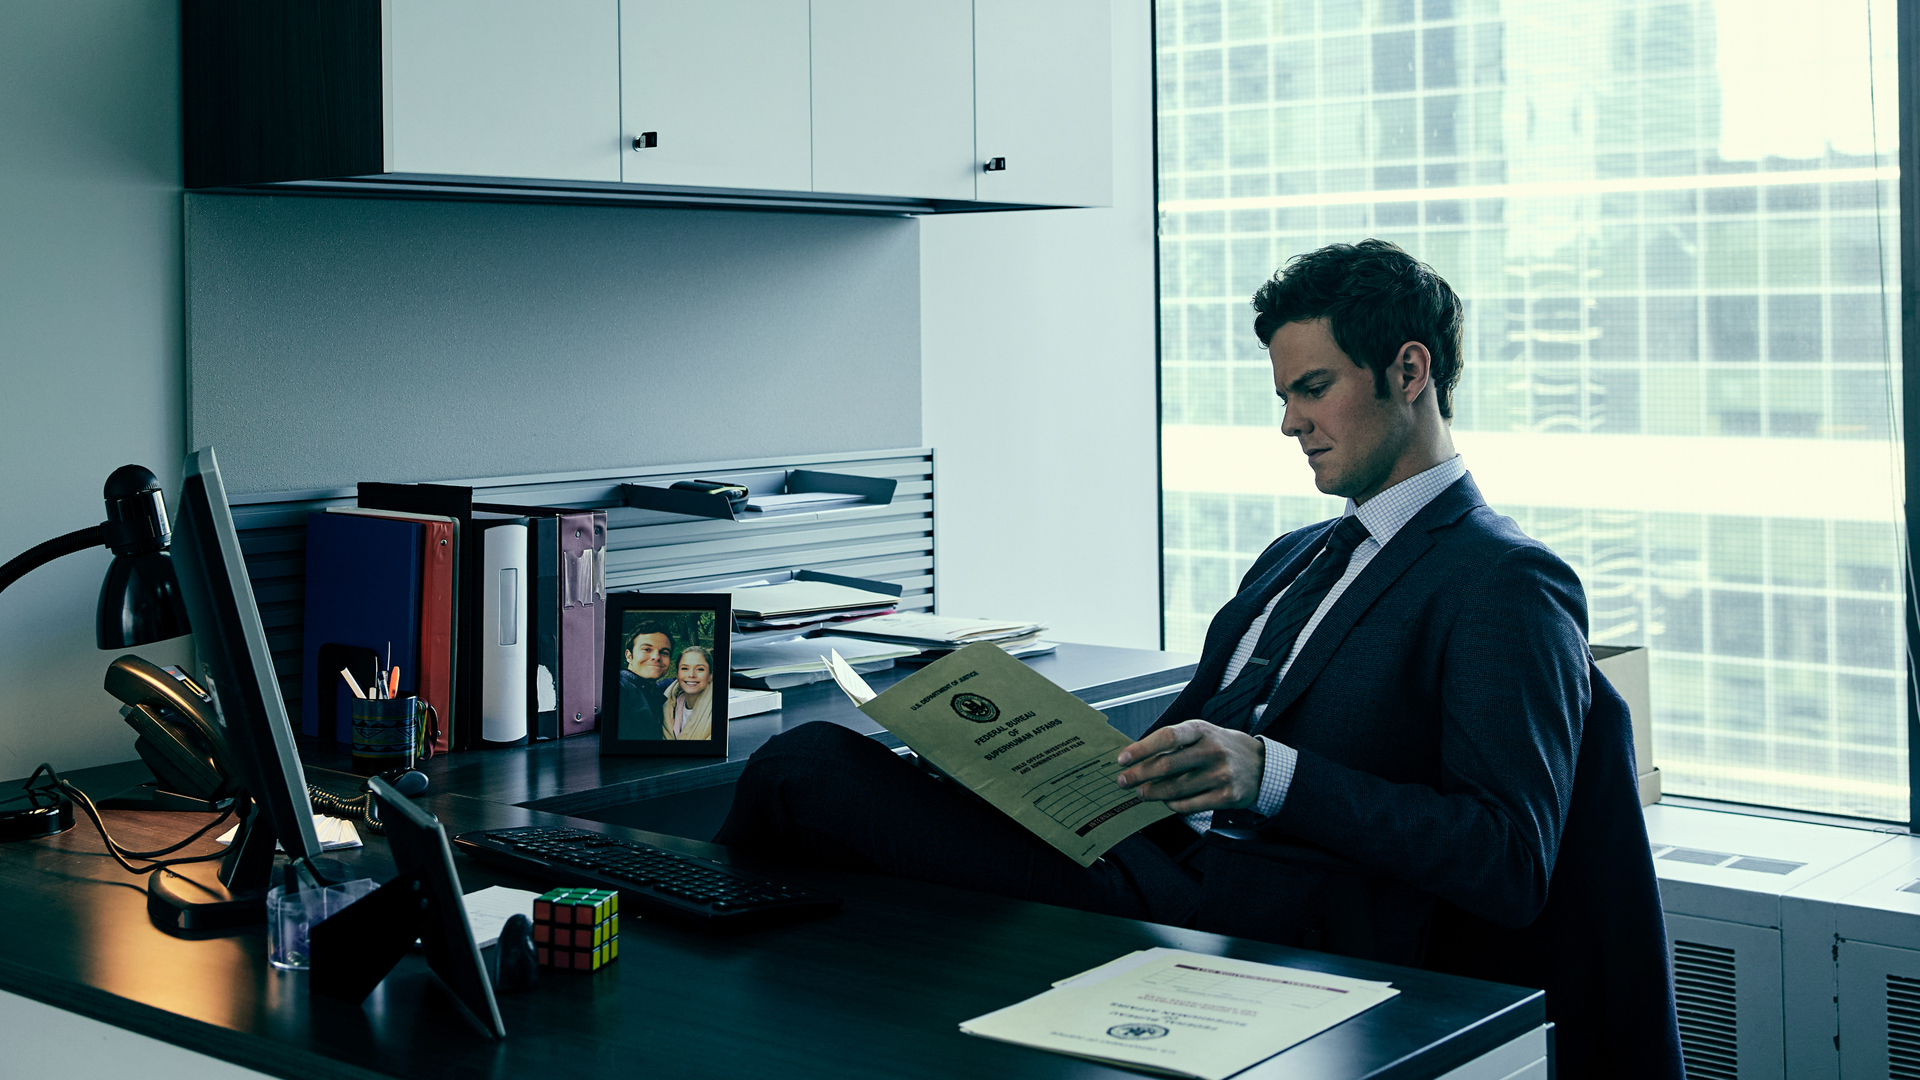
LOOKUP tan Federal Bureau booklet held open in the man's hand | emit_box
[828,642,1173,867]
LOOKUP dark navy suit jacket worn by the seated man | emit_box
[1156,470,1678,1076]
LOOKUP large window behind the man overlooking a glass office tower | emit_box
[1158,0,1908,821]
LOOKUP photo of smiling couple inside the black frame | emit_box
[620,611,726,742]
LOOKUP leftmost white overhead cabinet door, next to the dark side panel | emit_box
[384,0,620,181]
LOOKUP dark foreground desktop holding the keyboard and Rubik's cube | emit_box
[0,767,1544,1080]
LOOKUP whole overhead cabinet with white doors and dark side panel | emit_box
[182,0,1112,213]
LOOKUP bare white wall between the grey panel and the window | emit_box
[920,0,1160,648]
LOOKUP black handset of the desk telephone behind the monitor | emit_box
[106,653,240,801]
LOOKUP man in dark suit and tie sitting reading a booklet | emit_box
[716,240,1674,1074]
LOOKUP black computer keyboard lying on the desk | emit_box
[453,828,841,930]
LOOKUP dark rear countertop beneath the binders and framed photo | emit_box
[301,644,1194,815]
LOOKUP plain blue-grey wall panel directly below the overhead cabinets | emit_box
[186,194,920,492]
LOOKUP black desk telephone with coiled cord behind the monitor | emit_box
[106,653,426,818]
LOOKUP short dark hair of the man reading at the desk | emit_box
[1254,240,1465,419]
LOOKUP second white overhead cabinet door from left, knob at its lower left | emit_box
[620,0,812,192]
